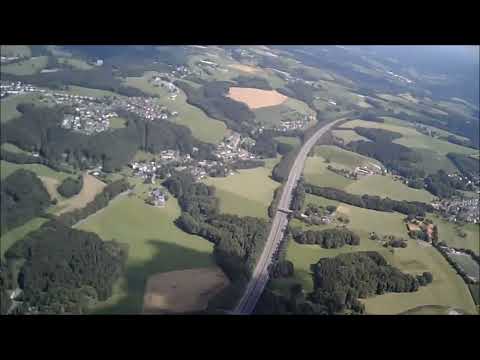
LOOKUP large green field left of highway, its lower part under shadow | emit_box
[78,185,214,313]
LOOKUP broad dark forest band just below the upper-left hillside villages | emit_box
[1,105,213,172]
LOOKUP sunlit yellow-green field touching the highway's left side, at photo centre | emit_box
[205,160,279,219]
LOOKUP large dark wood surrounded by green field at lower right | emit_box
[309,251,433,314]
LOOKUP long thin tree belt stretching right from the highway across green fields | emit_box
[305,183,434,216]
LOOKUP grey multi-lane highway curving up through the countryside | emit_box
[233,119,342,315]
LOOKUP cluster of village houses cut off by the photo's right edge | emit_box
[432,197,480,224]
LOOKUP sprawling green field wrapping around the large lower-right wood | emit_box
[274,194,476,314]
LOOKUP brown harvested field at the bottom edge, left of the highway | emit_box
[143,267,229,314]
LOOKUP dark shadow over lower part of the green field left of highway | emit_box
[90,239,214,314]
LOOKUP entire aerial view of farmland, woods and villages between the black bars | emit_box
[0,45,480,318]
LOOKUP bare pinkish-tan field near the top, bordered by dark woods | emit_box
[228,87,288,109]
